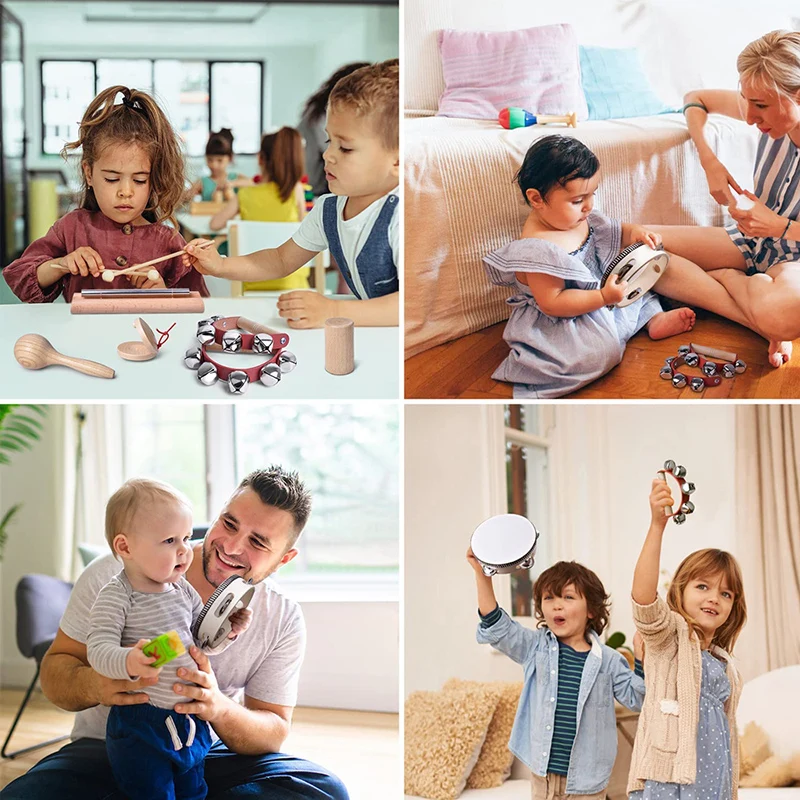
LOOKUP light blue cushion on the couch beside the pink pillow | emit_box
[580,47,678,119]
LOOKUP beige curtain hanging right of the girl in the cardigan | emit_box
[735,405,800,679]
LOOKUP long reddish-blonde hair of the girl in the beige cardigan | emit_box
[667,548,747,653]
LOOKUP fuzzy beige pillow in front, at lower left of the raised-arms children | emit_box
[404,686,500,800]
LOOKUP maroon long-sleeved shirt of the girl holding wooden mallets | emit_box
[3,208,208,303]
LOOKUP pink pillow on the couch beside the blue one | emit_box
[438,25,589,119]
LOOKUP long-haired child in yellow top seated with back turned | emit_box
[209,126,311,291]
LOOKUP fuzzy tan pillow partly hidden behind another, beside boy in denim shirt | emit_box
[443,678,522,789]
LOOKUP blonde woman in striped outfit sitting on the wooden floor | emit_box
[648,31,800,367]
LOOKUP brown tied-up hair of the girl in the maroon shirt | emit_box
[61,86,185,229]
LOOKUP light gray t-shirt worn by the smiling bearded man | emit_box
[60,554,306,739]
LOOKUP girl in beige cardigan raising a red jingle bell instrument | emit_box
[628,479,747,800]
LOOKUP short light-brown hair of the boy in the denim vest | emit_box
[328,58,400,152]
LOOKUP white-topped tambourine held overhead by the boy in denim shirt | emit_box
[470,514,539,578]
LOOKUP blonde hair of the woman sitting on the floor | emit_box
[736,30,800,102]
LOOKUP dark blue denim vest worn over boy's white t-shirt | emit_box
[322,194,400,300]
